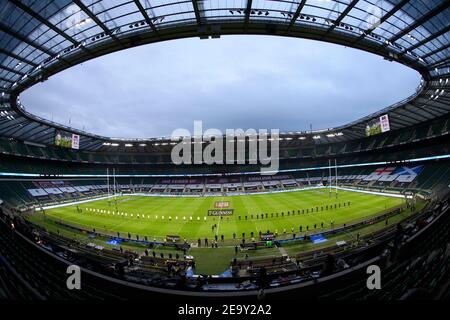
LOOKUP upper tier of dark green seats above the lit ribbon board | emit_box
[0,132,450,175]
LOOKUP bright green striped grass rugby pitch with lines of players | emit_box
[37,189,405,241]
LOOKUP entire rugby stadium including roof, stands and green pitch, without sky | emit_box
[0,0,450,301]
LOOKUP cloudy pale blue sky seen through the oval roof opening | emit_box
[21,36,420,138]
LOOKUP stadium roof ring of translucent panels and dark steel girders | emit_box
[0,0,450,150]
